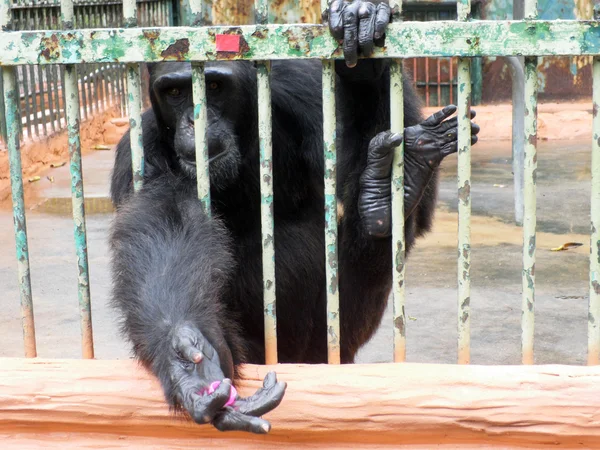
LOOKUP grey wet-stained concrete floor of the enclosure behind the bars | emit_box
[0,139,590,364]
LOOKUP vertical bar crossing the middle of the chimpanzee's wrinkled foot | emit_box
[390,60,406,362]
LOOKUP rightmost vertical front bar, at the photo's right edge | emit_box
[588,57,600,364]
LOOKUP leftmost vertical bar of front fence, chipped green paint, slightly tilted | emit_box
[0,0,37,358]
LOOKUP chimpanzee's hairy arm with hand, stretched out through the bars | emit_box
[110,176,285,433]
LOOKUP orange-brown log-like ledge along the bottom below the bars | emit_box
[0,358,600,449]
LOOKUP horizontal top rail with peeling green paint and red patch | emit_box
[0,20,600,66]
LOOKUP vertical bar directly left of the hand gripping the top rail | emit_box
[323,61,340,364]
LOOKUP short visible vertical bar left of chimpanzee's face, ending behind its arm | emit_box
[123,0,144,191]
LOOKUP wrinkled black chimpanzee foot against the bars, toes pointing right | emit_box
[358,105,479,238]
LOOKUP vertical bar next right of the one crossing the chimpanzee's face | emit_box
[254,0,280,364]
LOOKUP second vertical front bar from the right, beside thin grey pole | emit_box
[521,0,538,364]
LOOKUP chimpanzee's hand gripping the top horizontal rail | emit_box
[328,0,391,67]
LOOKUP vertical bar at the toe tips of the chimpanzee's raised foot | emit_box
[457,58,471,364]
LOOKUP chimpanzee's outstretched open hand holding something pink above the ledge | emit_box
[167,325,286,434]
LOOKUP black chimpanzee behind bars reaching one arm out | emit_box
[110,0,479,433]
